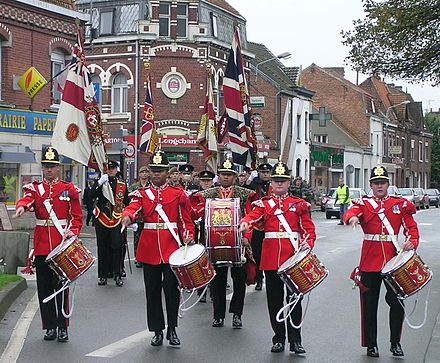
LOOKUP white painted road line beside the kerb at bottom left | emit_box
[0,293,38,363]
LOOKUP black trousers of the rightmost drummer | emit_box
[361,272,404,347]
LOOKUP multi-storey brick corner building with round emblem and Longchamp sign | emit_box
[76,0,251,182]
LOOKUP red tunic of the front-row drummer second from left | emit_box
[122,184,194,265]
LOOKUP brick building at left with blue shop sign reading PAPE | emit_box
[0,0,85,205]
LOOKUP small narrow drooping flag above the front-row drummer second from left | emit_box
[139,76,159,154]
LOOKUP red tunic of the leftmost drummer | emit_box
[16,180,82,256]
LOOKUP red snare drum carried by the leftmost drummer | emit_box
[46,236,95,283]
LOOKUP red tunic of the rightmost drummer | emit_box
[344,196,419,272]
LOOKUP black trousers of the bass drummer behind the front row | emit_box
[212,266,246,319]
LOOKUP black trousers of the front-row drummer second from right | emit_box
[264,271,302,344]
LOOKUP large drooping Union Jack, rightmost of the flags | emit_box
[223,29,257,168]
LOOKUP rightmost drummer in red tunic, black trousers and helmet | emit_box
[344,165,419,357]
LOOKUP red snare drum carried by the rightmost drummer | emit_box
[382,250,432,299]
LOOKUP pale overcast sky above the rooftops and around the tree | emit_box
[227,0,440,111]
